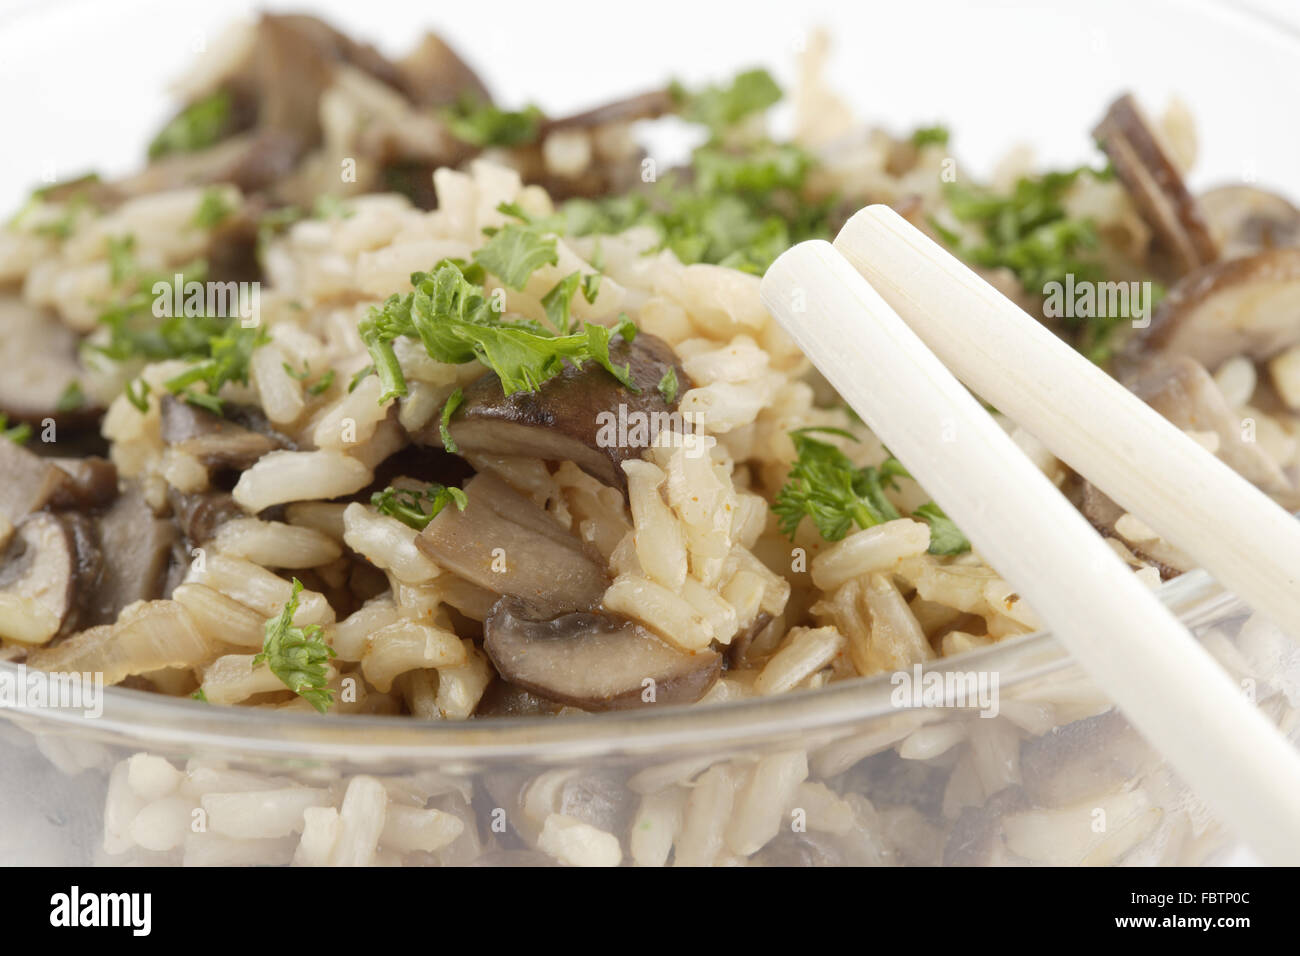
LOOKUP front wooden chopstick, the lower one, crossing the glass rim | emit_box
[762,242,1300,864]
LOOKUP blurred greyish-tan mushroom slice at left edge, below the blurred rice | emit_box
[0,295,103,425]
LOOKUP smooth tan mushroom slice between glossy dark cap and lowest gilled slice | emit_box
[416,473,610,615]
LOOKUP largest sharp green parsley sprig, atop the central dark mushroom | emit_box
[358,259,637,402]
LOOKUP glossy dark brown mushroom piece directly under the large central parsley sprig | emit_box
[441,333,690,489]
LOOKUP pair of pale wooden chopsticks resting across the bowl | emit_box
[762,206,1300,865]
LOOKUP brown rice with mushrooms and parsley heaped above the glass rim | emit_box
[0,14,1300,719]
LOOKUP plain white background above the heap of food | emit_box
[0,0,1300,209]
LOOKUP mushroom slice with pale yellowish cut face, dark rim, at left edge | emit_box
[0,511,78,645]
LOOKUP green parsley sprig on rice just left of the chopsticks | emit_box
[772,428,970,554]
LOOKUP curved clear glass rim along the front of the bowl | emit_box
[0,570,1240,760]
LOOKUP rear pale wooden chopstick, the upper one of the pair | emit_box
[835,206,1300,642]
